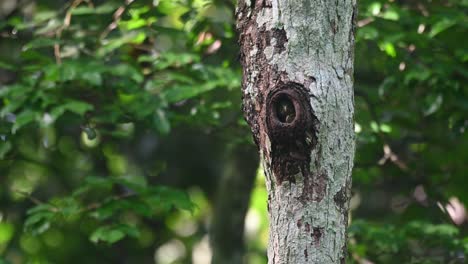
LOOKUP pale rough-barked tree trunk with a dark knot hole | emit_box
[236,0,356,264]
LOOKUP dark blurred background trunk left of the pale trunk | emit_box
[210,144,258,264]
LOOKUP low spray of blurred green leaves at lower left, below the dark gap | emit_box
[24,177,195,243]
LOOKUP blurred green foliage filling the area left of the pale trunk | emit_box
[0,0,241,263]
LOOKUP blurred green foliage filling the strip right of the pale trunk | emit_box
[349,0,468,263]
